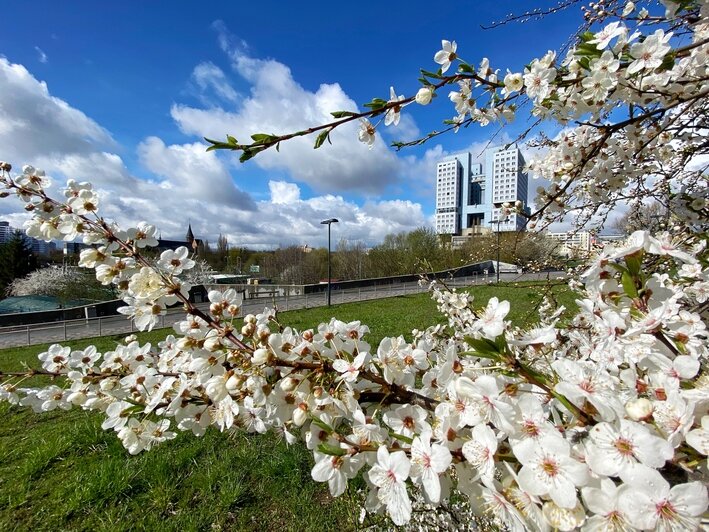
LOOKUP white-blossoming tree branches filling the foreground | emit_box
[0,0,709,530]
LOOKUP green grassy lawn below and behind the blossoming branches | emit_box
[0,283,574,531]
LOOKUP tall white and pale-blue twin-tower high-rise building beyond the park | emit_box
[436,146,529,236]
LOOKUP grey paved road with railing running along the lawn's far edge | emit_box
[0,272,561,348]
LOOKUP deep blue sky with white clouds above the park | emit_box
[0,0,580,248]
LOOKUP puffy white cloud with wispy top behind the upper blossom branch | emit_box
[171,24,404,195]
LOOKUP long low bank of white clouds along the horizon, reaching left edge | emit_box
[0,58,426,249]
